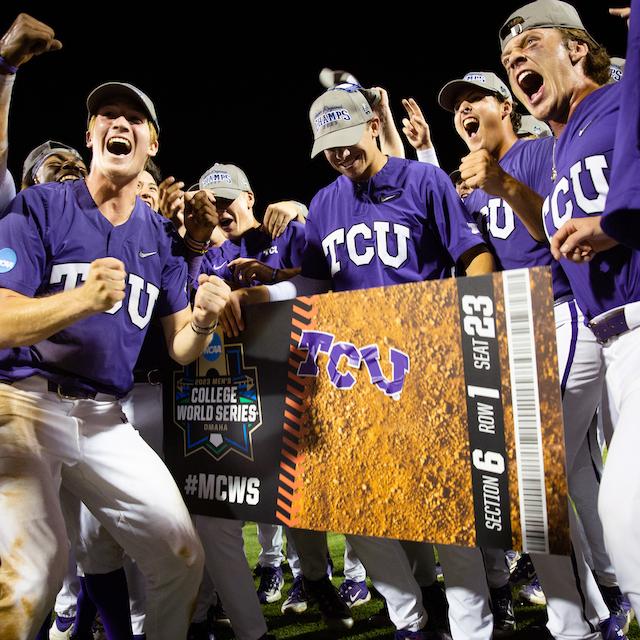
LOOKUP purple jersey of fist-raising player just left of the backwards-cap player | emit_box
[464,138,571,299]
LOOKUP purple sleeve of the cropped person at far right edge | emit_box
[602,0,640,250]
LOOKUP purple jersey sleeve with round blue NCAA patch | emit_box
[0,190,47,297]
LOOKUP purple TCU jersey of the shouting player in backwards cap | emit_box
[543,83,640,320]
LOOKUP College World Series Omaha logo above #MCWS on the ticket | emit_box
[173,330,262,460]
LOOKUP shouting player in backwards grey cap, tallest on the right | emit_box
[500,0,640,624]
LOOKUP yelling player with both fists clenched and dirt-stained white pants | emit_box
[0,83,229,640]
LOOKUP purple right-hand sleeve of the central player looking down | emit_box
[427,170,484,262]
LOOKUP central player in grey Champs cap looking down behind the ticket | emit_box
[270,85,493,639]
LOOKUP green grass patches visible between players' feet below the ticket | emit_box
[206,523,640,640]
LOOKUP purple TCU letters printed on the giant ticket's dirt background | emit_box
[298,331,410,400]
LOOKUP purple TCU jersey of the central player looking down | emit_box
[302,158,483,291]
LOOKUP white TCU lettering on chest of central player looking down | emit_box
[322,221,411,276]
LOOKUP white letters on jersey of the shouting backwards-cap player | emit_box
[542,155,609,229]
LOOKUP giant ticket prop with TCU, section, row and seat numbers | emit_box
[165,268,569,553]
